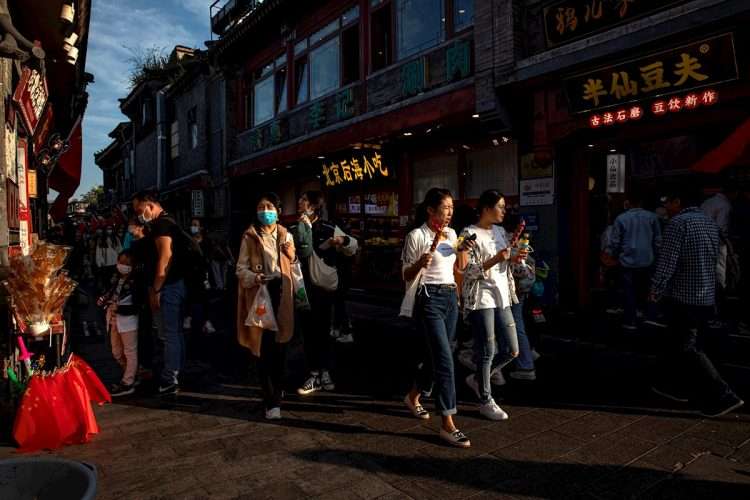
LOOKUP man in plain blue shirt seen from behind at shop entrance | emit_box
[607,191,661,330]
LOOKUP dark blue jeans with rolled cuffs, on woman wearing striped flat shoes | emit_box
[414,285,458,417]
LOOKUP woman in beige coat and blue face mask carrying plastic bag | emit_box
[237,193,296,420]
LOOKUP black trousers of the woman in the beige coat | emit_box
[256,279,286,409]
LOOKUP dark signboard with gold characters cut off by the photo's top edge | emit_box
[544,0,680,47]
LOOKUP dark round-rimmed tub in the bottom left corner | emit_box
[0,456,96,500]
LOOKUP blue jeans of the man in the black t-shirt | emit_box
[154,280,186,384]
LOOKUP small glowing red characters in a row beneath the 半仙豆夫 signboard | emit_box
[589,89,719,128]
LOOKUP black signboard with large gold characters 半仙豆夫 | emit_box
[563,33,738,113]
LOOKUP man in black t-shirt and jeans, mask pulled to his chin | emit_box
[133,188,187,394]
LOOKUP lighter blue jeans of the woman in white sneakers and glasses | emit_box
[470,307,518,404]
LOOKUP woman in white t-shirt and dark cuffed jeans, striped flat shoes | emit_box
[401,188,473,448]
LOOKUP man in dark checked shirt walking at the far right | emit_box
[649,184,744,417]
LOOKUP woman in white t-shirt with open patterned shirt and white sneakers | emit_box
[462,190,518,420]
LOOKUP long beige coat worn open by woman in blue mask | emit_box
[237,225,294,356]
